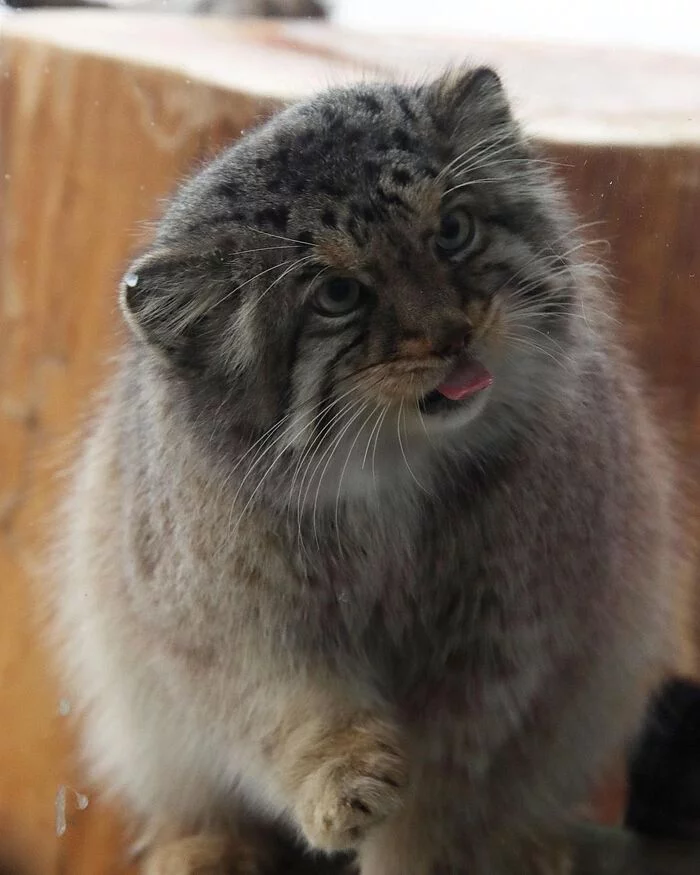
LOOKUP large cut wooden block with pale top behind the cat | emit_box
[0,11,700,875]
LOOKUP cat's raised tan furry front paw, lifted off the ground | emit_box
[297,721,408,851]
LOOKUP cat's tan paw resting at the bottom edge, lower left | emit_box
[141,835,254,875]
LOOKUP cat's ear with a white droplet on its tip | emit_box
[119,249,209,368]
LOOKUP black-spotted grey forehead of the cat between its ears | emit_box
[161,87,443,242]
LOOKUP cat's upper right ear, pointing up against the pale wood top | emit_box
[432,67,522,143]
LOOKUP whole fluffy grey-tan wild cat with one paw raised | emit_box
[56,68,675,875]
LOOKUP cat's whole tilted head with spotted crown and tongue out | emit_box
[121,68,588,504]
